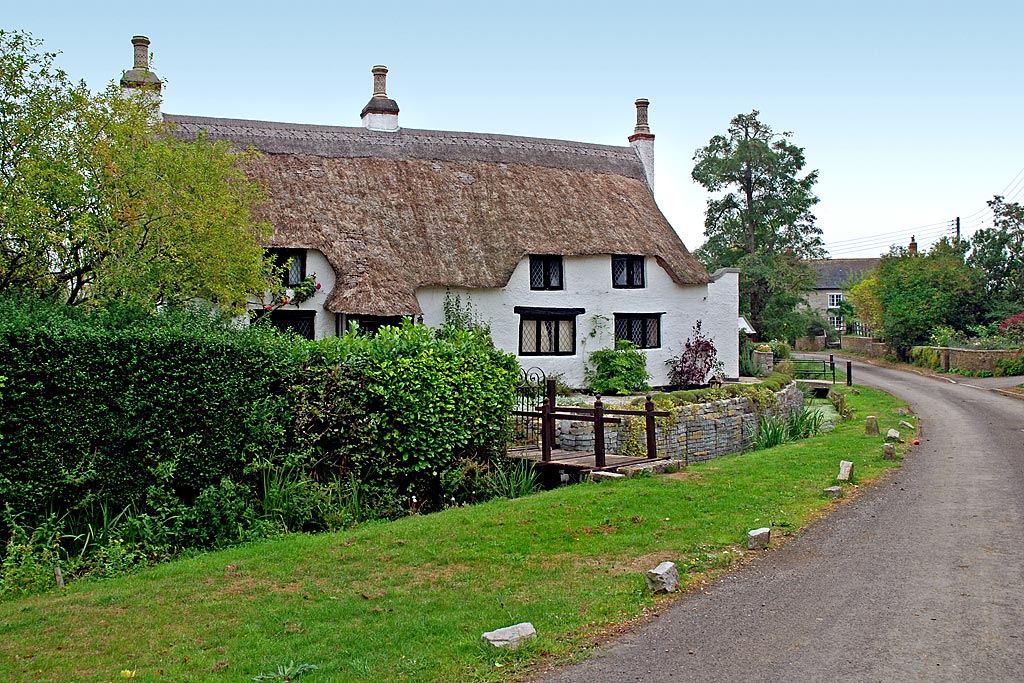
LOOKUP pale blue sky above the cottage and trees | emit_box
[0,0,1024,257]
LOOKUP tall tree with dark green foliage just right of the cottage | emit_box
[692,110,824,337]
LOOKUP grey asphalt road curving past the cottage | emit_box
[538,361,1024,683]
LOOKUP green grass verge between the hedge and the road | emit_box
[0,387,915,683]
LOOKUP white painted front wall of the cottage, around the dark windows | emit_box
[417,255,739,387]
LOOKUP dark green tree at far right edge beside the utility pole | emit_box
[968,196,1024,319]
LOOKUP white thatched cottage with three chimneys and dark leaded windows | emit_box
[122,37,738,385]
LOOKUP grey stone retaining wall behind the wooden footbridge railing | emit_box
[555,382,804,463]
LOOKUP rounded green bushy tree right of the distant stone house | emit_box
[872,239,985,358]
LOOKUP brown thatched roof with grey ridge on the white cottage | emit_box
[165,115,711,315]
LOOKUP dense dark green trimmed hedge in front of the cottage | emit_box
[0,299,518,547]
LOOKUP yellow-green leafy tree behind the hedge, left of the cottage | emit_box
[0,31,272,310]
